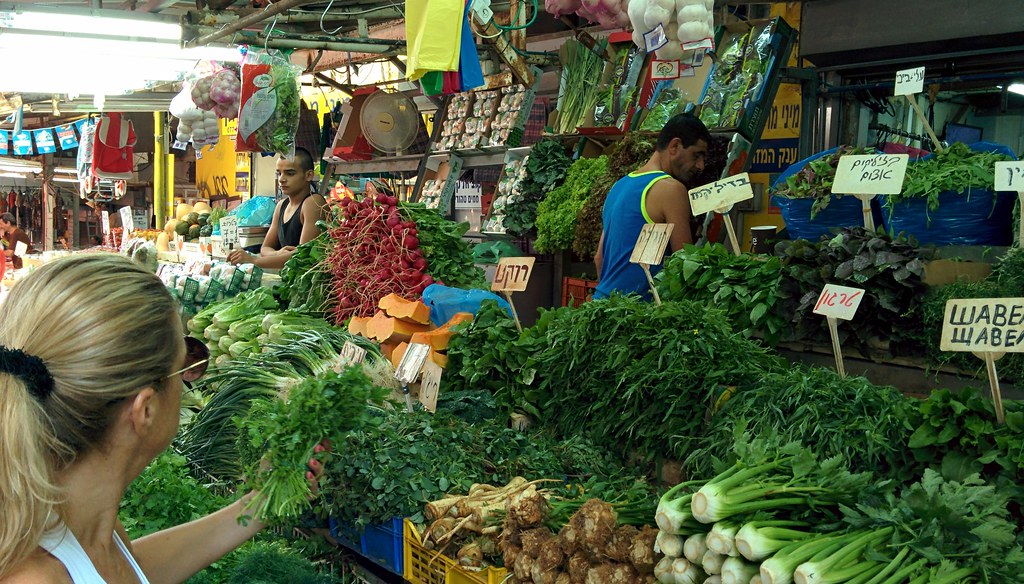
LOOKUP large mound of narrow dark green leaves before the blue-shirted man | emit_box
[527,296,781,458]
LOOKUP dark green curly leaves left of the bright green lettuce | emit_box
[505,138,572,236]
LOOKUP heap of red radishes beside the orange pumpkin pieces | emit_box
[328,187,434,325]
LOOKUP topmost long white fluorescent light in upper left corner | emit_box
[0,9,181,42]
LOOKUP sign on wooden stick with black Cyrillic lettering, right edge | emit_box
[939,298,1024,423]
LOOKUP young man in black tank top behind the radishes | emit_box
[227,148,327,269]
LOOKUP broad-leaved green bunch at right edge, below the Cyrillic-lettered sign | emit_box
[908,388,1024,519]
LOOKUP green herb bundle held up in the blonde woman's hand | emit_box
[237,367,387,523]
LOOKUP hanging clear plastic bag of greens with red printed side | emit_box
[234,49,301,157]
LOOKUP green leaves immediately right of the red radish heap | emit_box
[398,203,487,289]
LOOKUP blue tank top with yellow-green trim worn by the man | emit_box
[594,170,669,300]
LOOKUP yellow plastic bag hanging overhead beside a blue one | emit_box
[406,0,466,81]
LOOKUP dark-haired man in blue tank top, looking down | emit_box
[594,114,711,300]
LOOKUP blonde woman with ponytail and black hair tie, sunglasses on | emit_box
[0,254,322,584]
